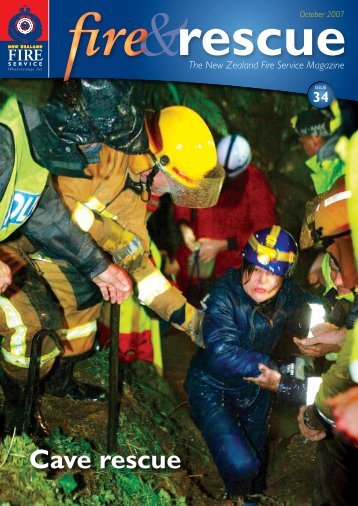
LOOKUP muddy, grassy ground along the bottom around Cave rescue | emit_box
[0,332,314,506]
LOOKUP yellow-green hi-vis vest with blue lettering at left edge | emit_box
[0,97,48,241]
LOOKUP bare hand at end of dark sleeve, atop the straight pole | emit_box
[92,264,133,304]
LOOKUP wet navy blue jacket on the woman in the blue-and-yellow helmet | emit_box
[189,269,319,395]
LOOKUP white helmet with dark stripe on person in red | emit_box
[216,134,252,177]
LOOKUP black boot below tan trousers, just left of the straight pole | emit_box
[45,358,107,401]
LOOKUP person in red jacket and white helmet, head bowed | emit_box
[174,134,276,292]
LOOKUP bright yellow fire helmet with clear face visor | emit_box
[131,106,225,208]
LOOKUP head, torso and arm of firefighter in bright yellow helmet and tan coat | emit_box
[50,102,224,360]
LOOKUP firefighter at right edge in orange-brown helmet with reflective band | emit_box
[298,178,358,506]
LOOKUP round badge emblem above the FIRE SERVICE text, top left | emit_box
[8,6,42,44]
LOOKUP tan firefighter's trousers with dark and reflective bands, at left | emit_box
[0,237,101,381]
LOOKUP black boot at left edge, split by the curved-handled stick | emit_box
[0,370,50,439]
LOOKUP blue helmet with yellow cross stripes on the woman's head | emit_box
[242,225,298,277]
